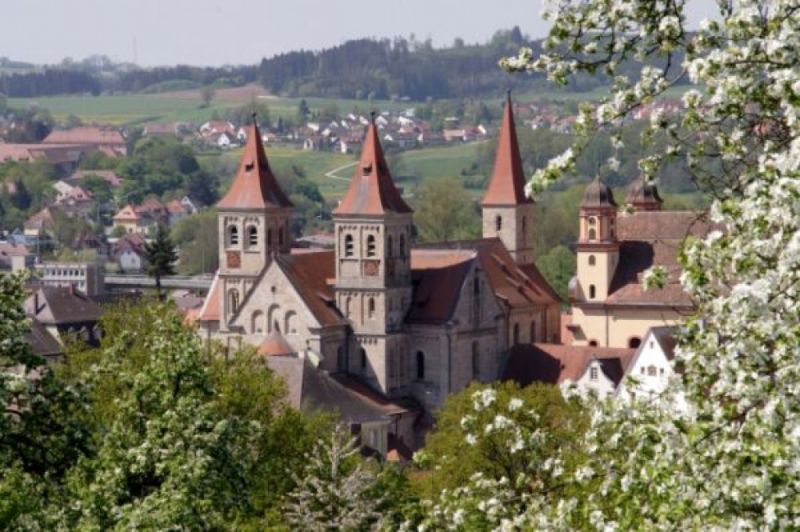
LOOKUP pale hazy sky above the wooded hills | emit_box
[0,0,713,66]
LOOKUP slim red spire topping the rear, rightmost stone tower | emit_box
[481,91,533,206]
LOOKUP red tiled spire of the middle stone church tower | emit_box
[334,116,412,215]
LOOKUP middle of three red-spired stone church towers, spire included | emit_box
[333,114,412,395]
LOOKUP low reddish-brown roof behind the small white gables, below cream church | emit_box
[502,343,636,386]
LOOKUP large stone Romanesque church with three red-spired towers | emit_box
[196,98,561,422]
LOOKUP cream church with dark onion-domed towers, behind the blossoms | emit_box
[564,172,711,349]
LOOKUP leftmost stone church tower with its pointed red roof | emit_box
[217,115,293,331]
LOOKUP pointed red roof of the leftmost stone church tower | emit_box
[217,120,293,209]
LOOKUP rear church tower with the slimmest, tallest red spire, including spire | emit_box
[481,93,534,264]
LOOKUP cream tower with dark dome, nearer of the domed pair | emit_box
[573,176,619,303]
